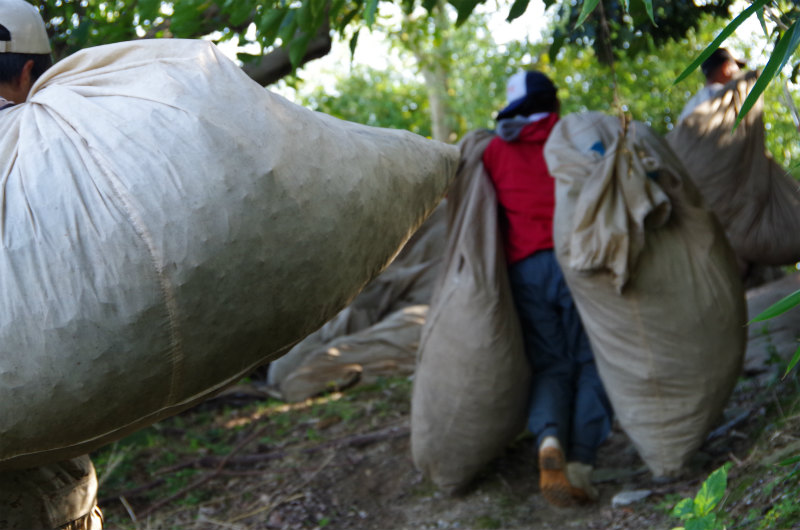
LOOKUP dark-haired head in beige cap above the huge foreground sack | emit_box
[0,0,53,109]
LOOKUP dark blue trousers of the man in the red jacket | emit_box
[509,250,613,465]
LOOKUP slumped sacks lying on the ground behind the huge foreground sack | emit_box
[268,201,447,402]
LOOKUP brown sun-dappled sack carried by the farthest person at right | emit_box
[667,72,800,265]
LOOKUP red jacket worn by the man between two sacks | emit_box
[483,113,558,265]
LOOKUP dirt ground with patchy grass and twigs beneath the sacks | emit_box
[94,270,800,530]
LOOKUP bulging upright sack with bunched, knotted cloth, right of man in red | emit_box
[545,112,746,476]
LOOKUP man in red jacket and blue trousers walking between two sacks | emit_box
[483,71,612,506]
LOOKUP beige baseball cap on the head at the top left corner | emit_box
[0,0,50,54]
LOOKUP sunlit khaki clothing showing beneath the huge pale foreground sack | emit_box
[0,455,103,530]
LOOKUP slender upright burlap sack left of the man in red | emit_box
[411,131,530,492]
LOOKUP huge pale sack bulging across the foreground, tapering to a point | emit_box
[0,39,458,467]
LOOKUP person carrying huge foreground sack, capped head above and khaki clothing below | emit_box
[0,5,103,530]
